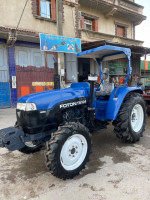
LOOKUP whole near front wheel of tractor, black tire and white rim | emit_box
[45,122,91,180]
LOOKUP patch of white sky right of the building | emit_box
[135,0,150,48]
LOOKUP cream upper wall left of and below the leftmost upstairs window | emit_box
[0,0,56,34]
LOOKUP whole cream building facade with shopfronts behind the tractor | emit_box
[0,0,146,107]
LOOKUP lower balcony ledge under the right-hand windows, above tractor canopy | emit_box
[81,29,143,47]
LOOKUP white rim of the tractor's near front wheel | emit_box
[60,134,88,171]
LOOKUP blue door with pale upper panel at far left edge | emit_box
[0,45,10,108]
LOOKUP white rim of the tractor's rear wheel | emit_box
[131,104,144,132]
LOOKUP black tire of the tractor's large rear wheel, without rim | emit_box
[113,93,146,143]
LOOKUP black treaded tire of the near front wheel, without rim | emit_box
[45,122,92,180]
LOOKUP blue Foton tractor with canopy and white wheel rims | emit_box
[0,45,146,179]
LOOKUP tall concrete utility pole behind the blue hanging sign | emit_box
[56,0,64,86]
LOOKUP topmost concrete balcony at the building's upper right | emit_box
[79,0,146,25]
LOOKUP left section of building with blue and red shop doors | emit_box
[0,0,78,107]
